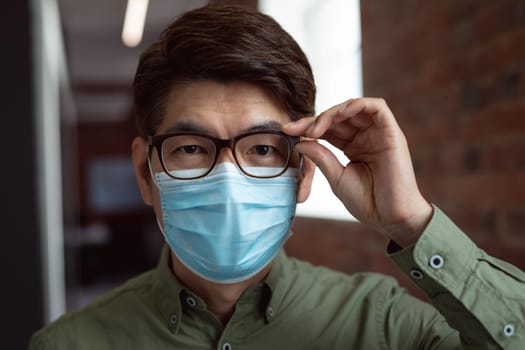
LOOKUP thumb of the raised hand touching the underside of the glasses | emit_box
[295,141,344,189]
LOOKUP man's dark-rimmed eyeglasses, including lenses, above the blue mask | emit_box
[148,131,299,180]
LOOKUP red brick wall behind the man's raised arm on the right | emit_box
[288,0,525,298]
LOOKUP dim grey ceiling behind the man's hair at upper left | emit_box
[58,0,208,122]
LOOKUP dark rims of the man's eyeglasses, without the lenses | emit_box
[148,130,300,180]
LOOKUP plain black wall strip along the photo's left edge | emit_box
[0,1,44,349]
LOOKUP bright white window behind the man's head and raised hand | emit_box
[259,0,363,220]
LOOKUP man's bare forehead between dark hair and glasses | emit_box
[158,80,291,137]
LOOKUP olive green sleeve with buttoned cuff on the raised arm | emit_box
[389,206,525,349]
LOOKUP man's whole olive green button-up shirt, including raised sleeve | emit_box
[29,208,525,350]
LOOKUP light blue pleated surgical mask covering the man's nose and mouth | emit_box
[155,163,298,283]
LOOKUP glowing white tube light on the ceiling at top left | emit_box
[122,0,149,47]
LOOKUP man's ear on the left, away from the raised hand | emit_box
[131,136,153,205]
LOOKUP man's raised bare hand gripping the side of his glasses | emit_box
[283,98,432,247]
